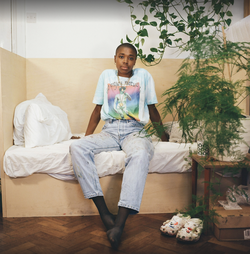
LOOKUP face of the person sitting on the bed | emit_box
[114,47,136,77]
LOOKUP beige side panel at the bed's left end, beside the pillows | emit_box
[0,48,26,212]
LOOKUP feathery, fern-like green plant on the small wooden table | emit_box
[162,35,250,159]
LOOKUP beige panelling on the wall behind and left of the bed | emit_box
[0,48,246,216]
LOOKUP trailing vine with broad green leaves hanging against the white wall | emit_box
[117,0,234,66]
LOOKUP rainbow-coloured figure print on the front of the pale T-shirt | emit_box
[108,82,140,121]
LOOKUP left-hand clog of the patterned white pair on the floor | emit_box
[160,213,191,236]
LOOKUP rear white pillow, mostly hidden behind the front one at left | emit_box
[13,93,52,146]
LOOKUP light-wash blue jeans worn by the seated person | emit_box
[70,120,154,212]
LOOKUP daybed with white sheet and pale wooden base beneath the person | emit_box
[4,136,196,217]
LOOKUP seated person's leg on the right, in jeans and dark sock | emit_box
[107,121,154,249]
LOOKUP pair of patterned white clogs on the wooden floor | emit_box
[160,213,203,242]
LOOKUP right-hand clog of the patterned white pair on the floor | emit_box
[176,218,203,242]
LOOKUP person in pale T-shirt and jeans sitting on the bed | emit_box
[70,43,168,249]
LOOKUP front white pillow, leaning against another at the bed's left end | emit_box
[24,103,72,148]
